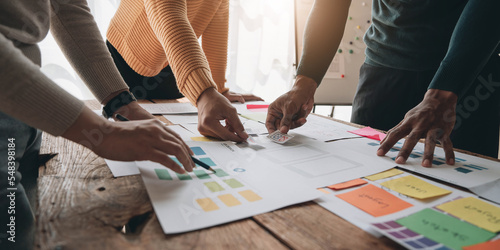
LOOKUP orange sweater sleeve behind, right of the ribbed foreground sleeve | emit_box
[202,0,229,93]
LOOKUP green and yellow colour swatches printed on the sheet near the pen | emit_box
[154,146,262,212]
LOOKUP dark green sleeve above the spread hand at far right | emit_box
[429,0,500,98]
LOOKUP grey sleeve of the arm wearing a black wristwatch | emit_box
[50,0,128,103]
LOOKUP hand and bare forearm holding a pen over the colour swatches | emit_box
[62,108,195,173]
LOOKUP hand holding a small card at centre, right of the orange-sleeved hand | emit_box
[266,75,318,134]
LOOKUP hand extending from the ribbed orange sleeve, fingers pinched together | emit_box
[197,88,248,142]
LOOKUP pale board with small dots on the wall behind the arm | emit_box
[295,0,372,105]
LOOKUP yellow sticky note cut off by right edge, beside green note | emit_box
[438,197,500,233]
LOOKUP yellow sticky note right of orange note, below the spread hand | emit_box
[380,175,451,199]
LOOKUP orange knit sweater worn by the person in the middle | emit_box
[107,0,229,104]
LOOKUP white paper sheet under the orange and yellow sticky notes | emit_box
[314,173,475,237]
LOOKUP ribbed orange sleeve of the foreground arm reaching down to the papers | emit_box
[144,0,217,104]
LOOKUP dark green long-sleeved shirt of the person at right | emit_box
[297,0,500,99]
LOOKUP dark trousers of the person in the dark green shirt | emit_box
[351,54,500,158]
